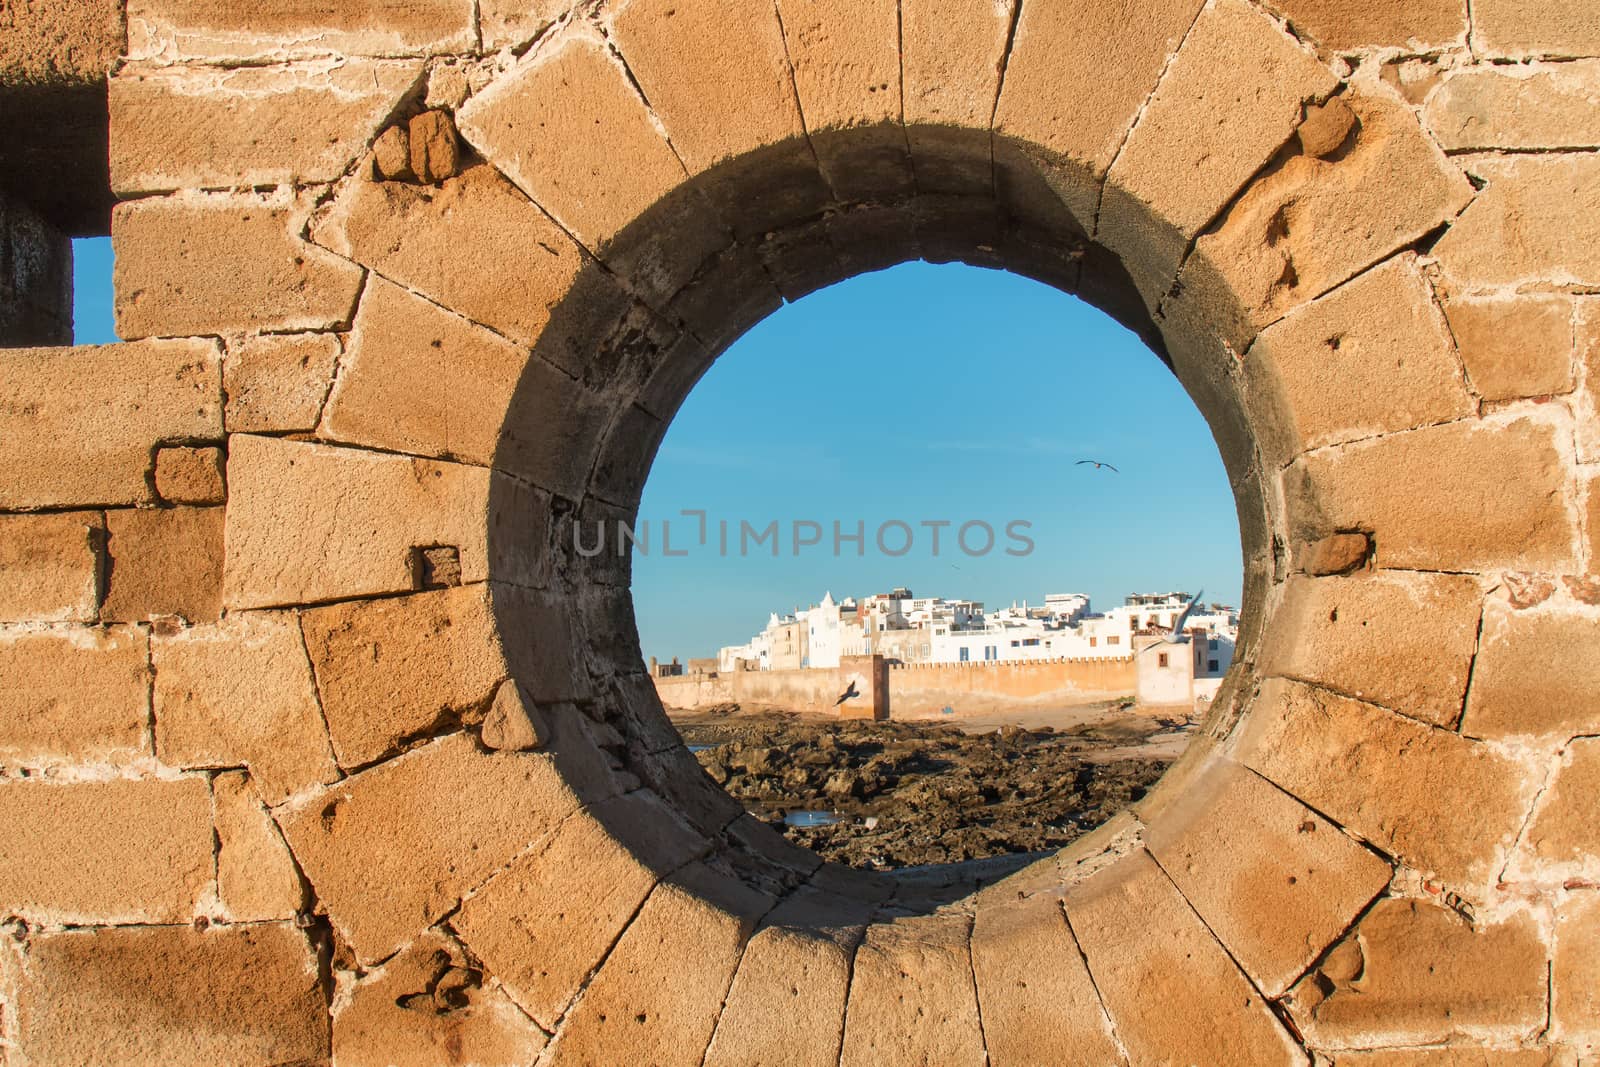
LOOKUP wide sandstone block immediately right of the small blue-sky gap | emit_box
[112,192,362,339]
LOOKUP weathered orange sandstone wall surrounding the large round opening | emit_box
[0,0,1600,1067]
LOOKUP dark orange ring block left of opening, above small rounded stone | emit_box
[301,584,507,768]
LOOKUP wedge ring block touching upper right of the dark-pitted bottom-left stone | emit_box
[451,792,709,1030]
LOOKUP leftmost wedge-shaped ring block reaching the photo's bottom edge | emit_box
[550,864,773,1067]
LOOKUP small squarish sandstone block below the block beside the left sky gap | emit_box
[222,333,341,434]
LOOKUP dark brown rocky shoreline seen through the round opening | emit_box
[674,705,1189,870]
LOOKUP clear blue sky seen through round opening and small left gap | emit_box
[75,238,1240,659]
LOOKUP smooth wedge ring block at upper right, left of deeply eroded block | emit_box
[1098,0,1336,299]
